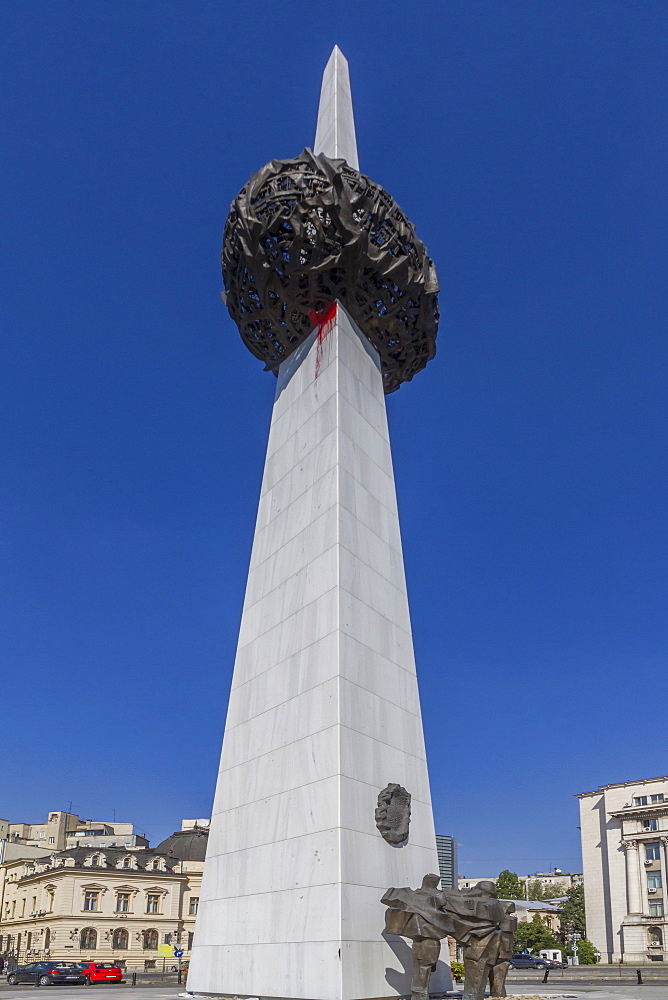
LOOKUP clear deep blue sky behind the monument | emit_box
[0,0,668,875]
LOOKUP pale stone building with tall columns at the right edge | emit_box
[578,777,668,962]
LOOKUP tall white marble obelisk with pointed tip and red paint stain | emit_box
[188,49,449,1000]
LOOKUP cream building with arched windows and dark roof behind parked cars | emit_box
[0,826,208,970]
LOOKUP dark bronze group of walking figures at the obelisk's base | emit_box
[382,875,517,1000]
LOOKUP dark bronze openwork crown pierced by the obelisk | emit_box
[222,149,438,393]
